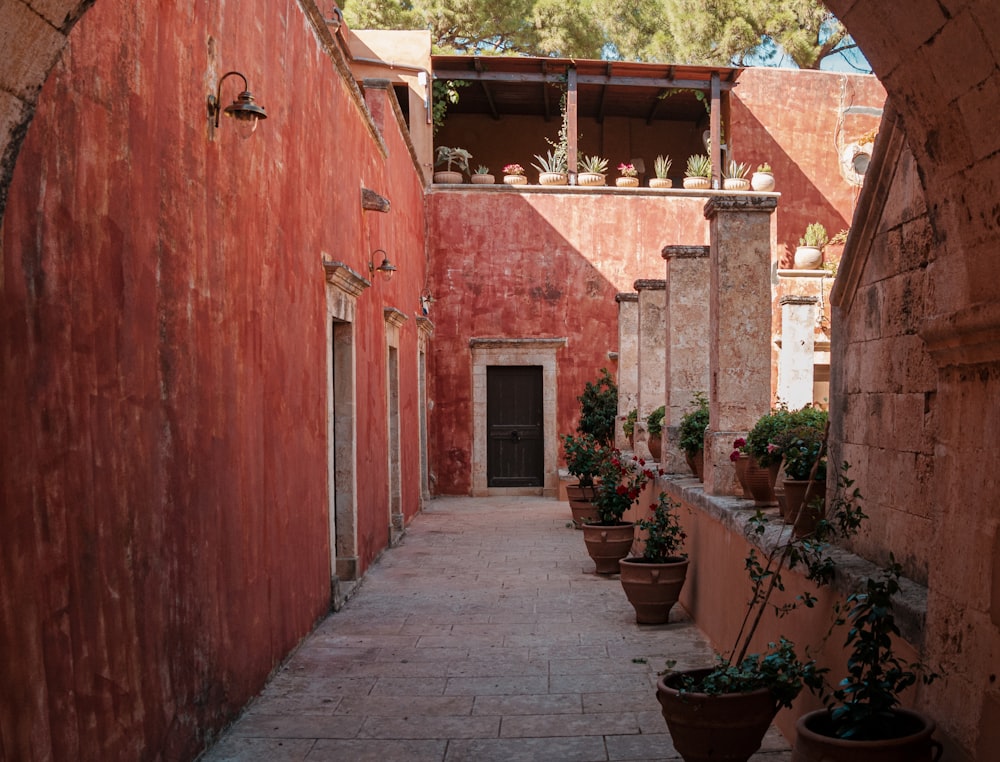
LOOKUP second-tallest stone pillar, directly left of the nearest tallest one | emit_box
[660,246,709,474]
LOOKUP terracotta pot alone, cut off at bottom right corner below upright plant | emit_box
[792,709,943,762]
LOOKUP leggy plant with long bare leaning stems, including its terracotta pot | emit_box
[657,464,866,760]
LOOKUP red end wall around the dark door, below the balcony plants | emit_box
[428,186,708,494]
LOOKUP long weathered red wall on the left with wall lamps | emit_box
[0,0,424,760]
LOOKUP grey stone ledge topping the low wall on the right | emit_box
[657,474,927,650]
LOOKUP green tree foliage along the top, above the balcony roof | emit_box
[344,0,855,69]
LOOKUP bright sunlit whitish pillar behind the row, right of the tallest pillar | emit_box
[778,296,819,410]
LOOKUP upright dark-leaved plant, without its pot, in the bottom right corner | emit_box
[823,554,938,741]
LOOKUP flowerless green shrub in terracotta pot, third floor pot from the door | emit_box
[619,492,688,624]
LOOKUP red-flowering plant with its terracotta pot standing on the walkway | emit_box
[583,449,658,574]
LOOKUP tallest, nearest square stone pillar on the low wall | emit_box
[705,195,778,495]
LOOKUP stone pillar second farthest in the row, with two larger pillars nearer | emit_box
[633,280,667,458]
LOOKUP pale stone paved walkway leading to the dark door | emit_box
[203,497,790,762]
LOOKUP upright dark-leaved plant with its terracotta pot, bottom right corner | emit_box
[792,555,942,762]
